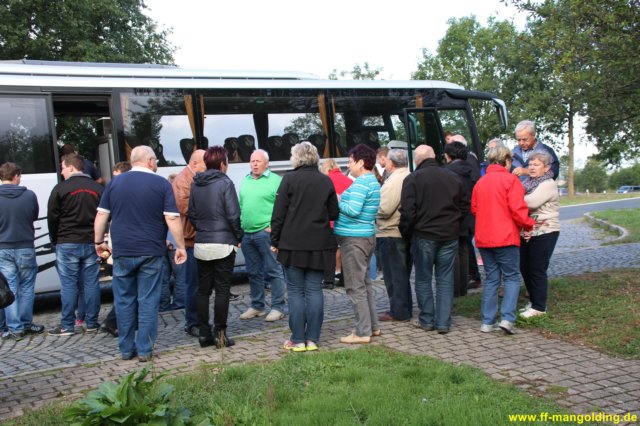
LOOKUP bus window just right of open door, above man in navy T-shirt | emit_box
[120,90,189,167]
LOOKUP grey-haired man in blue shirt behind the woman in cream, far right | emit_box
[511,120,560,182]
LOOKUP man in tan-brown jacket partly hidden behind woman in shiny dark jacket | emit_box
[171,149,207,337]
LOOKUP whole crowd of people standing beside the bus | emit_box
[0,121,560,362]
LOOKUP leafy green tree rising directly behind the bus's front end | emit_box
[412,16,543,147]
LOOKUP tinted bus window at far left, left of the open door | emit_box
[0,96,56,173]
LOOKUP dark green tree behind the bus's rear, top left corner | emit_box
[0,0,174,64]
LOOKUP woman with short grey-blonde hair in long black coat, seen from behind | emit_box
[271,142,339,352]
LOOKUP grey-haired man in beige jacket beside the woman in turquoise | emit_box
[376,149,413,321]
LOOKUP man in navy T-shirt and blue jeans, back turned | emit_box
[94,145,187,362]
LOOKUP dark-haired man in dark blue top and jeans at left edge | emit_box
[0,163,44,339]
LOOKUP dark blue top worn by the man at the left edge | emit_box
[0,183,39,249]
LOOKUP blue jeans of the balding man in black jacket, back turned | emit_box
[411,236,458,330]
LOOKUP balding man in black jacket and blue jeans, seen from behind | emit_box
[400,145,469,334]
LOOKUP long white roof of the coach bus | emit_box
[0,59,463,89]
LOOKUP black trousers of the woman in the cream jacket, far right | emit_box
[520,232,560,312]
